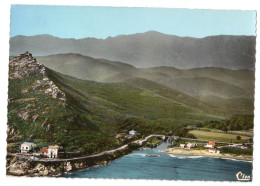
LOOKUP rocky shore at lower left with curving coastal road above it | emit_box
[6,134,163,177]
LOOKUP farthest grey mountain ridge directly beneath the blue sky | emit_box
[10,31,256,70]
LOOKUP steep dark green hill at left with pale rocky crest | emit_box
[7,54,120,154]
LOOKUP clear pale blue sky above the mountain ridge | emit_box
[10,5,256,39]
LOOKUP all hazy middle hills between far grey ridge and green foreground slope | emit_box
[37,53,254,115]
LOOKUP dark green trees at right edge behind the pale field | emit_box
[197,115,254,131]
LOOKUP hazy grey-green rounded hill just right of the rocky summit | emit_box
[37,54,135,82]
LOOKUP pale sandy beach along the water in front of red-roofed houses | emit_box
[165,147,253,161]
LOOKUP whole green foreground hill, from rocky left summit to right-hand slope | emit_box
[7,53,228,153]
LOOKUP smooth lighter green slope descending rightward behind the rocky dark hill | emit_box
[45,67,224,125]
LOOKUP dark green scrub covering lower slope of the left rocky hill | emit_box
[7,69,120,154]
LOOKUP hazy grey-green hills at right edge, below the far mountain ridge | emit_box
[144,67,255,99]
